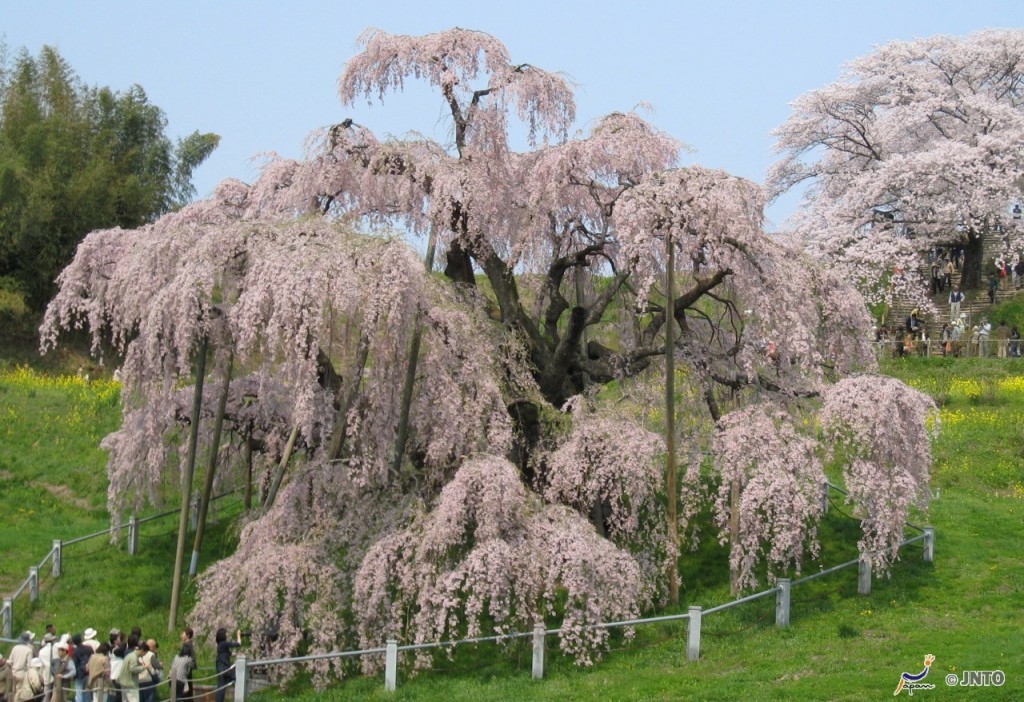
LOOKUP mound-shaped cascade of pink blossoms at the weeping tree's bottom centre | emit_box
[354,456,645,666]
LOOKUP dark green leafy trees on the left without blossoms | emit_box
[0,44,220,316]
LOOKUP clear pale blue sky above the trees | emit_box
[0,0,1024,229]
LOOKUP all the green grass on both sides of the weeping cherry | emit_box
[0,359,1024,702]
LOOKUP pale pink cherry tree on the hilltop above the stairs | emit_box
[768,29,1024,300]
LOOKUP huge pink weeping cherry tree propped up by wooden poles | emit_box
[43,30,929,679]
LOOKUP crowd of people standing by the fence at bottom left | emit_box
[0,624,242,702]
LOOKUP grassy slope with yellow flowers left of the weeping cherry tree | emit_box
[0,355,241,664]
